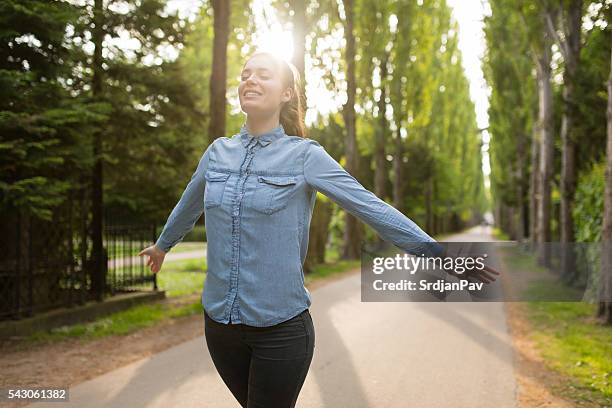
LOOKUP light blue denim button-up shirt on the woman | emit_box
[156,123,443,327]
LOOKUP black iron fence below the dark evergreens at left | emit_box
[0,193,157,320]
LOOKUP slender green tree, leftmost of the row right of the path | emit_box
[484,0,539,240]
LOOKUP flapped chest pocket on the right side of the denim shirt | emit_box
[252,176,297,214]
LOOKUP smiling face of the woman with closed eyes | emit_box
[238,54,291,116]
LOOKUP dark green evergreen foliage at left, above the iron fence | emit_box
[0,0,206,223]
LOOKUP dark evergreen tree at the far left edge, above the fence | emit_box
[0,1,109,306]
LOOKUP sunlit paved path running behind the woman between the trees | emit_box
[32,227,516,408]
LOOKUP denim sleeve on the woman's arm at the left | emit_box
[155,143,214,252]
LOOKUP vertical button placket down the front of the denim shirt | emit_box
[226,138,257,323]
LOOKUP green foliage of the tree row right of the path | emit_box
[483,0,612,242]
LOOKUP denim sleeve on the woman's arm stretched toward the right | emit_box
[304,139,445,256]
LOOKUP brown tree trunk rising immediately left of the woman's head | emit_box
[208,0,231,143]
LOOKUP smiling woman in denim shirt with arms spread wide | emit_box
[141,52,498,408]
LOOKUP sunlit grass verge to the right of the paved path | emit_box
[494,231,612,407]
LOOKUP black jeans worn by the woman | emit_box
[204,309,315,408]
